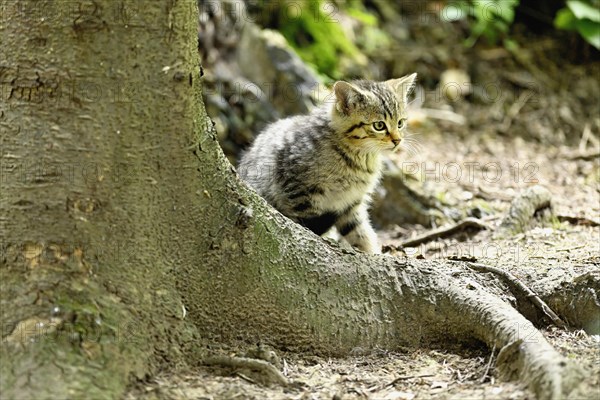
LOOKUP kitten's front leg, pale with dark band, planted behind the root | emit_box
[335,204,381,254]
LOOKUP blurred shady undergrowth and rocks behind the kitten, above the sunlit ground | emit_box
[198,0,600,161]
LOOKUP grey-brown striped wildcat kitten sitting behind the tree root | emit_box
[238,74,416,253]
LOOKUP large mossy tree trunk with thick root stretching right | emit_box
[0,0,578,398]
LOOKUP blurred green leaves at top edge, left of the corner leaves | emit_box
[442,0,519,47]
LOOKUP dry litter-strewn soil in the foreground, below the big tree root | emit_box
[126,329,600,400]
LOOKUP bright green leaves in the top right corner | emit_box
[554,0,600,50]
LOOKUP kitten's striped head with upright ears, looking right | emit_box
[332,74,417,152]
